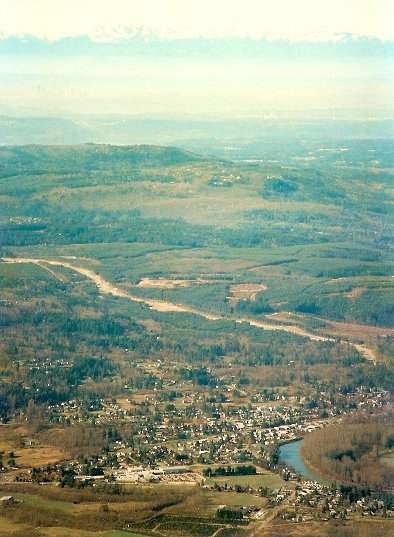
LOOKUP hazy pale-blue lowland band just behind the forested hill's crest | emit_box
[0,110,394,146]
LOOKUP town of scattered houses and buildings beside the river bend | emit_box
[0,363,391,522]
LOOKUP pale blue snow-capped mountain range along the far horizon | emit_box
[0,33,394,57]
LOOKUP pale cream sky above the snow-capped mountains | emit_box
[0,0,394,39]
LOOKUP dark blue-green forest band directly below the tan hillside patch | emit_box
[0,205,338,248]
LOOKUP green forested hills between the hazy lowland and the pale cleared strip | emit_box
[0,144,393,326]
